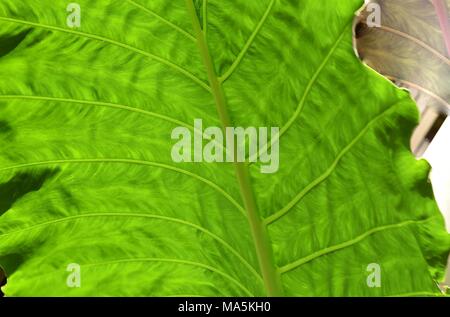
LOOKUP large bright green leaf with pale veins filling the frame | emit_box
[0,0,450,296]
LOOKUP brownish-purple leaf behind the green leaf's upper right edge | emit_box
[357,0,450,112]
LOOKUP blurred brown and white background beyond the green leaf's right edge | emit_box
[355,0,450,289]
